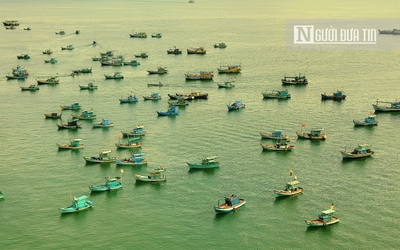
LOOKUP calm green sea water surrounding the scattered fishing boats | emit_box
[0,0,400,249]
